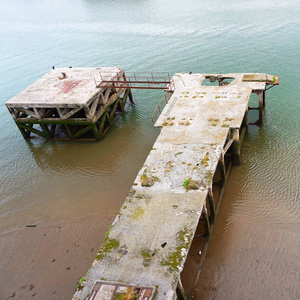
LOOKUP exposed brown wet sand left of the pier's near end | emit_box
[0,209,118,299]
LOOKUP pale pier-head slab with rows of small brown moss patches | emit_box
[155,87,252,128]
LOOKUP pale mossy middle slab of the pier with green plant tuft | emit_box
[133,142,223,193]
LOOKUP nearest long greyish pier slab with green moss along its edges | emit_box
[73,188,207,299]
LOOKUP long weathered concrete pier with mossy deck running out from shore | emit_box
[73,74,277,300]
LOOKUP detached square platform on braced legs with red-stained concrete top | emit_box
[6,67,133,140]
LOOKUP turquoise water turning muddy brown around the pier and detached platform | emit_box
[0,0,300,299]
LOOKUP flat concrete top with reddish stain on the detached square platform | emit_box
[6,67,124,108]
